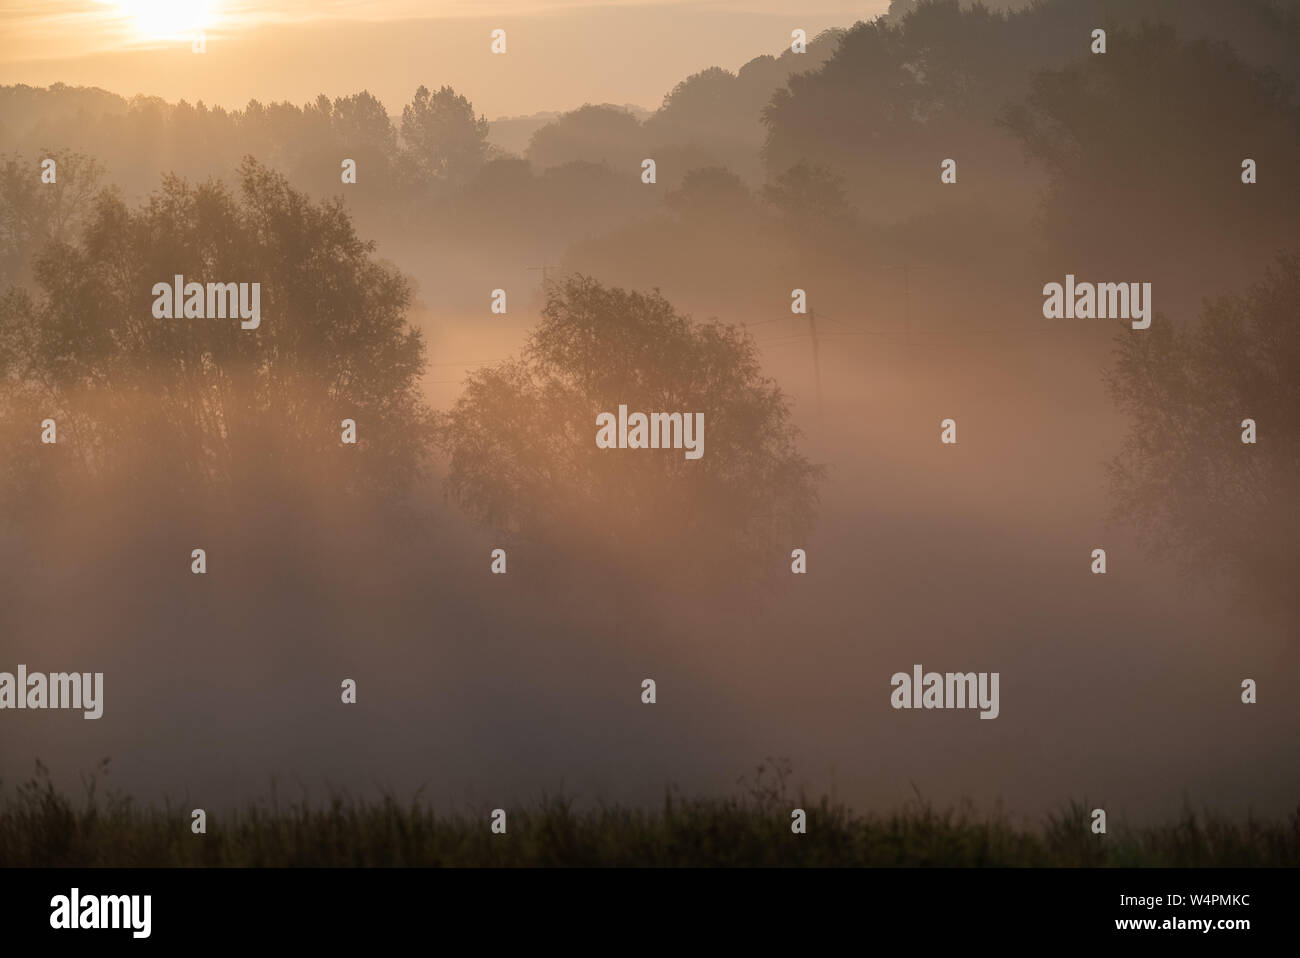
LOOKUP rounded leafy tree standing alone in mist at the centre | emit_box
[437,276,823,569]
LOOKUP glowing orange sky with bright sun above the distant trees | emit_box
[0,0,888,117]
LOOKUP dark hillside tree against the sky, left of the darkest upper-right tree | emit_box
[762,1,1024,220]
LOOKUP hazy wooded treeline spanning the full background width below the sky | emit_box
[0,0,1300,310]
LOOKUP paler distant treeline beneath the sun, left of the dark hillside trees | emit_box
[0,32,836,265]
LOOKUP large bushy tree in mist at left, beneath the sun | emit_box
[0,159,429,519]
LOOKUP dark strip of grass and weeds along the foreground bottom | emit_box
[0,763,1300,867]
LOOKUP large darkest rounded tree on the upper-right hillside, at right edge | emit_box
[1002,25,1300,289]
